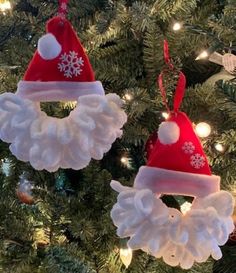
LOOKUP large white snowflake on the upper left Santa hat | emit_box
[58,51,84,78]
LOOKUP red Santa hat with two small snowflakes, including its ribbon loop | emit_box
[134,43,220,197]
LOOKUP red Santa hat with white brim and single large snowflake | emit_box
[14,16,104,101]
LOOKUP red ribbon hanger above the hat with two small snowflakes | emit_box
[157,40,186,113]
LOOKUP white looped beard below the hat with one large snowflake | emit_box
[0,93,127,172]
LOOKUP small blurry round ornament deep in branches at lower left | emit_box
[16,175,34,205]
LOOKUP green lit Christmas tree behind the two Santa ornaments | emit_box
[0,0,236,273]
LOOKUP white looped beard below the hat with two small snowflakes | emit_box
[111,181,234,269]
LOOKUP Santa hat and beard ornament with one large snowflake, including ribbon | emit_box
[0,1,127,172]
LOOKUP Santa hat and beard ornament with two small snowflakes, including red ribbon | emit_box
[111,42,234,269]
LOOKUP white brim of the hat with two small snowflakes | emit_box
[134,166,220,197]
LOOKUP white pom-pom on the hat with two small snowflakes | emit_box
[158,121,180,144]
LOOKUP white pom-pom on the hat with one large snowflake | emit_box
[38,33,61,60]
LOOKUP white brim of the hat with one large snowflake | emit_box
[16,81,105,102]
